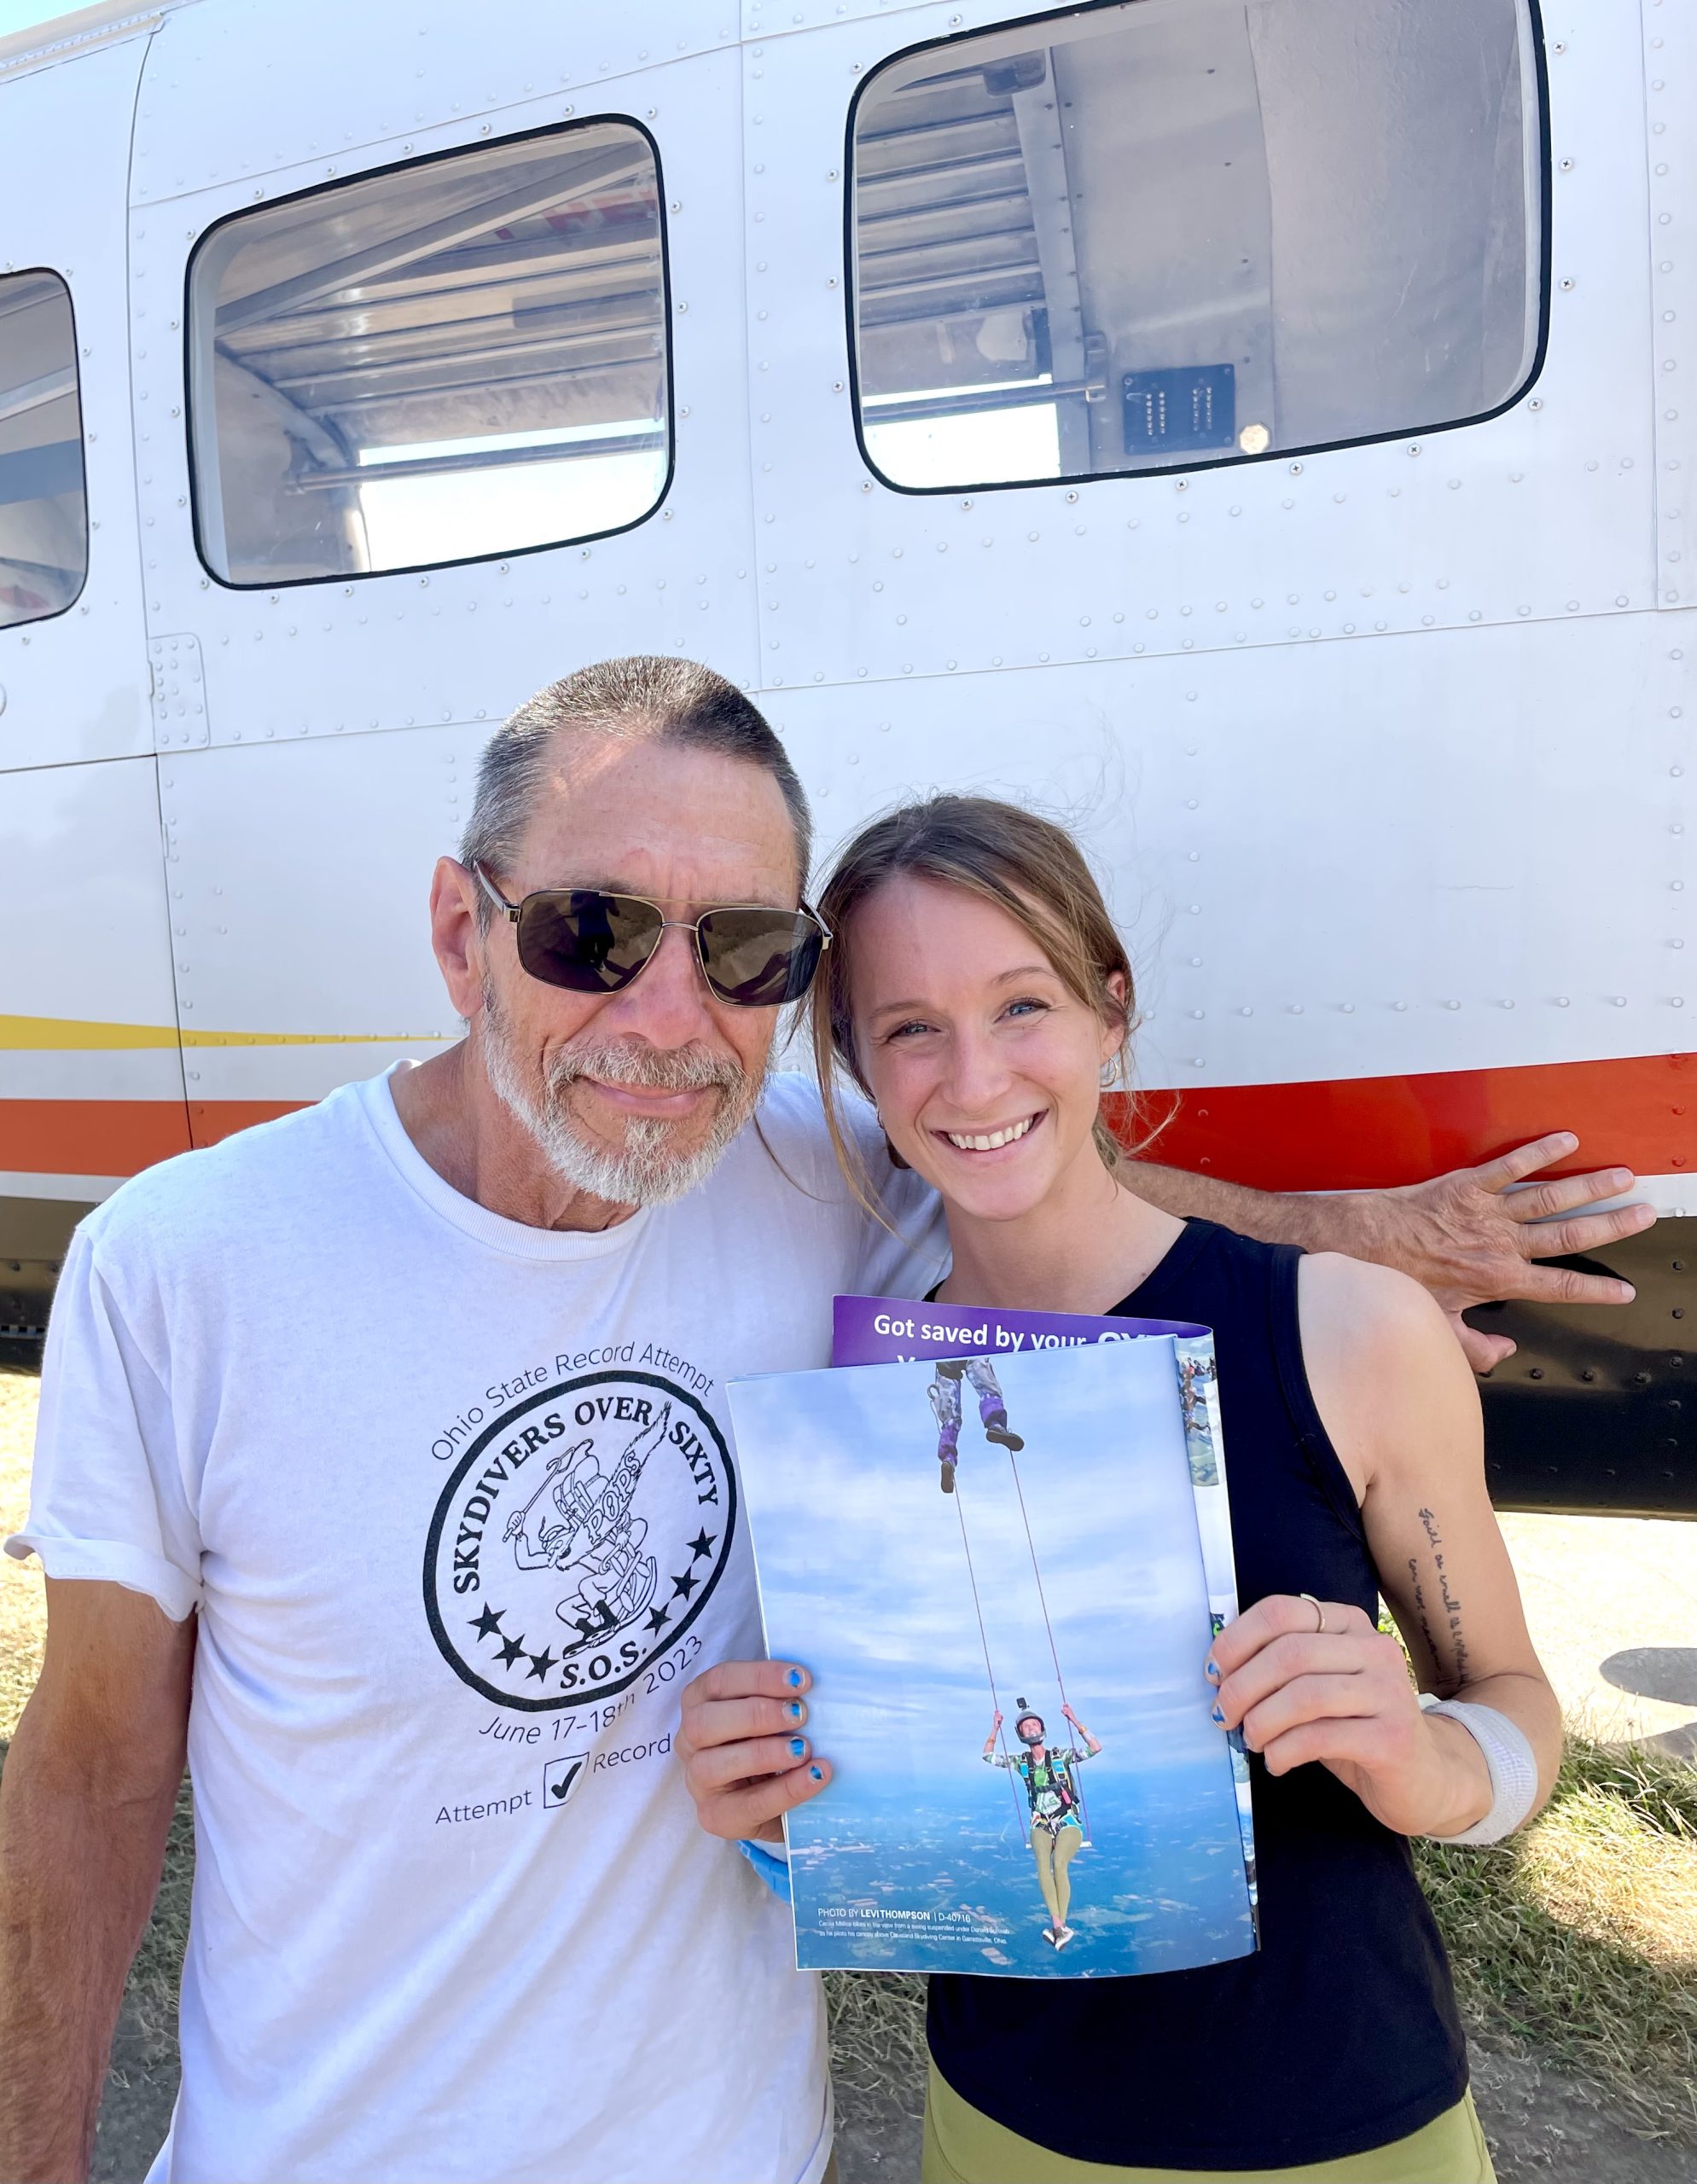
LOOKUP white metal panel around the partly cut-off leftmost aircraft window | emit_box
[0,39,153,773]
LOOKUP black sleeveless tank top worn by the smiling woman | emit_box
[928,1221,1467,2171]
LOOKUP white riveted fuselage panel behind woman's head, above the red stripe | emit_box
[773,612,1697,1088]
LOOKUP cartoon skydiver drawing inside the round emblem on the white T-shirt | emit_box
[507,1404,672,1660]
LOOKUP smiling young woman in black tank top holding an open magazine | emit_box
[679,797,1560,2184]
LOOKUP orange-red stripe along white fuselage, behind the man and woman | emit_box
[0,1054,1697,1190]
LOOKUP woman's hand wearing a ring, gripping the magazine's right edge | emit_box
[1208,1592,1491,1834]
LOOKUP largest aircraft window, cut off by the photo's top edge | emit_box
[851,0,1544,491]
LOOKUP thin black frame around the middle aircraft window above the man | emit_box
[183,112,677,592]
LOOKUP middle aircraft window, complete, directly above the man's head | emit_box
[190,122,671,585]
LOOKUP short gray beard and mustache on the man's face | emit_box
[479,985,762,1205]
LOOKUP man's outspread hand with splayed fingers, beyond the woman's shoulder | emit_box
[1339,1130,1655,1372]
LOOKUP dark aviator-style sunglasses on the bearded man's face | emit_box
[472,865,830,1009]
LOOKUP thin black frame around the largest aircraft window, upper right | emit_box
[843,0,1553,500]
